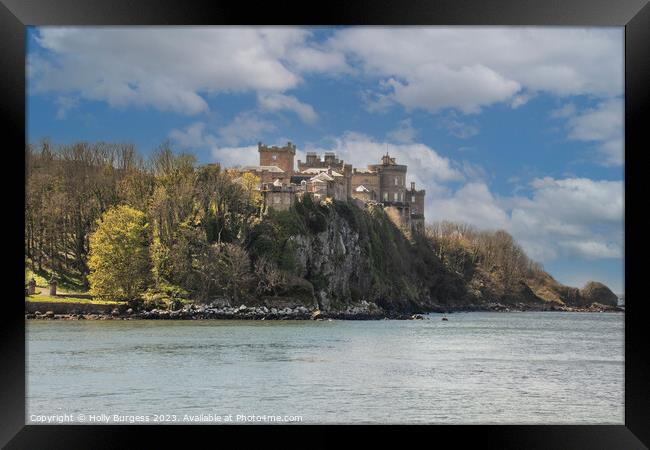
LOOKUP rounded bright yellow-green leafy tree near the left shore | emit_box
[88,205,150,300]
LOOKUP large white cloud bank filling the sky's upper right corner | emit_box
[328,27,623,112]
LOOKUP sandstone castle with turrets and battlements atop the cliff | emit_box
[231,142,425,232]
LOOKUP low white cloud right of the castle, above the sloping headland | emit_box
[426,174,624,262]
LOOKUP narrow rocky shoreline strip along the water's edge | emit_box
[25,303,625,321]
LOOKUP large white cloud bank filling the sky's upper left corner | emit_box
[29,27,309,114]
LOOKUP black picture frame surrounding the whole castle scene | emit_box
[0,0,650,449]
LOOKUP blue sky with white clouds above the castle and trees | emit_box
[26,26,624,294]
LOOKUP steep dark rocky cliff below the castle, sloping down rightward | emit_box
[247,202,616,315]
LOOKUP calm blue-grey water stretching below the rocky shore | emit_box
[27,312,624,424]
